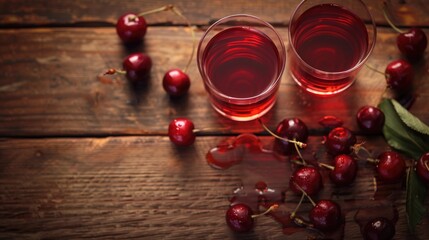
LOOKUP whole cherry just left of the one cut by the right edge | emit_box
[377,151,406,183]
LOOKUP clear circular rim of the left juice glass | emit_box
[197,13,286,102]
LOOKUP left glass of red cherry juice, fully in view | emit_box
[197,14,286,121]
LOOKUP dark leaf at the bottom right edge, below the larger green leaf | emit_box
[406,164,426,233]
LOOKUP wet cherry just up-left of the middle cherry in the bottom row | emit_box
[289,167,323,196]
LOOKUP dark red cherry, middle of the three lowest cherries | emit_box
[309,200,341,231]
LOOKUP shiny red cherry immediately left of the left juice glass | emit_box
[162,69,191,97]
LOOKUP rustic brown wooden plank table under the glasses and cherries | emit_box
[0,0,429,239]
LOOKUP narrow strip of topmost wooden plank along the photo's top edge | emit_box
[0,0,429,26]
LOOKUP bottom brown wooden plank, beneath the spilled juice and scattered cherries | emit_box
[0,137,429,239]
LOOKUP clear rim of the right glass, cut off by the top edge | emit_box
[288,0,377,75]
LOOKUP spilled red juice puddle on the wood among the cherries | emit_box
[206,134,345,239]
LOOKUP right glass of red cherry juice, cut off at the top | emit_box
[288,0,377,95]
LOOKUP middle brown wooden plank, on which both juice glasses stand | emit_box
[0,27,429,136]
